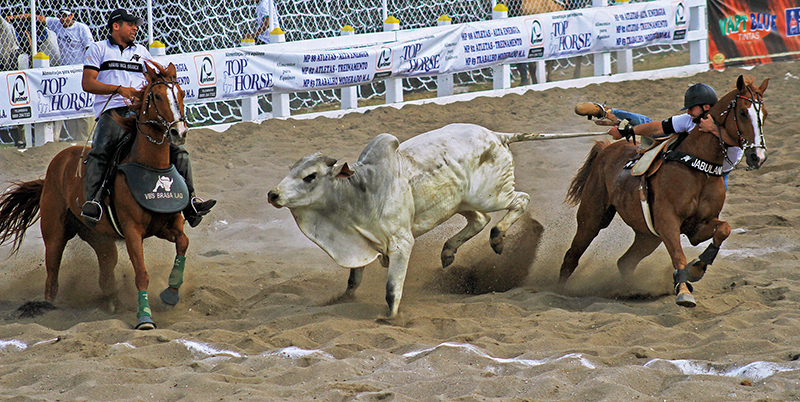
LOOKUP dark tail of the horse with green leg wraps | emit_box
[0,179,44,255]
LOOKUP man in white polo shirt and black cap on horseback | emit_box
[81,9,216,227]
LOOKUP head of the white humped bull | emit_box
[267,152,352,208]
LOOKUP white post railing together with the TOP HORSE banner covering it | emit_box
[0,0,708,146]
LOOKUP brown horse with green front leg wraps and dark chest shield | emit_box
[0,61,189,329]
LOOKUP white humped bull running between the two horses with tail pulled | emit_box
[267,124,539,317]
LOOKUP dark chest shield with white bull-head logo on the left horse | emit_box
[118,162,190,214]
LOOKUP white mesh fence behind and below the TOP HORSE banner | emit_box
[0,0,672,126]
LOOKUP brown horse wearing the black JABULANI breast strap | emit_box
[559,76,769,307]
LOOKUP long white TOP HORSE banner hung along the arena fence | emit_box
[0,1,688,126]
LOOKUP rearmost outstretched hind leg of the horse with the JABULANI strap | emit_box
[558,201,617,288]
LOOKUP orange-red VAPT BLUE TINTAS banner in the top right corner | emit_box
[708,0,800,69]
